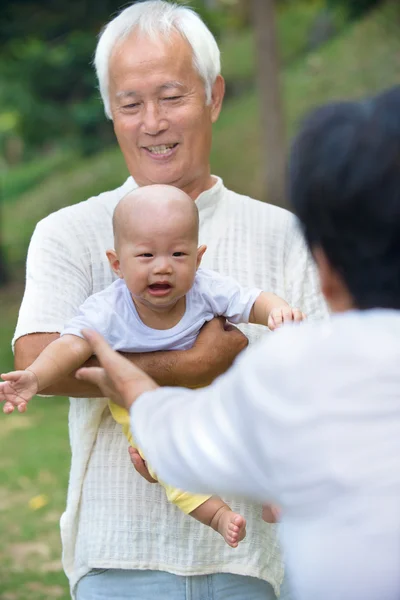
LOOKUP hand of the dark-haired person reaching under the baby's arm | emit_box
[76,330,158,410]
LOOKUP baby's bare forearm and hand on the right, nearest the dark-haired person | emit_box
[249,292,305,331]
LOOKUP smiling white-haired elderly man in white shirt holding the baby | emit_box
[15,0,325,600]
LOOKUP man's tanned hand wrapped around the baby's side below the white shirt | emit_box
[189,317,249,387]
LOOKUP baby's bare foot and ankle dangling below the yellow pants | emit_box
[189,496,246,548]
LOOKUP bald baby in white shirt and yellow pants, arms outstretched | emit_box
[0,185,304,548]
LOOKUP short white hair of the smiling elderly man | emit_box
[94,0,221,119]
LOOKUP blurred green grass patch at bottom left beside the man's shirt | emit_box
[0,398,69,600]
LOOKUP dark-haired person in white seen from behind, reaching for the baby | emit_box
[77,87,400,600]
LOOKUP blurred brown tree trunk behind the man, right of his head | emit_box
[252,0,287,206]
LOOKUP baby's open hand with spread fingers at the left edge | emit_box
[0,371,38,414]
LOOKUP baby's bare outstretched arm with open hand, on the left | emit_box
[0,335,92,414]
